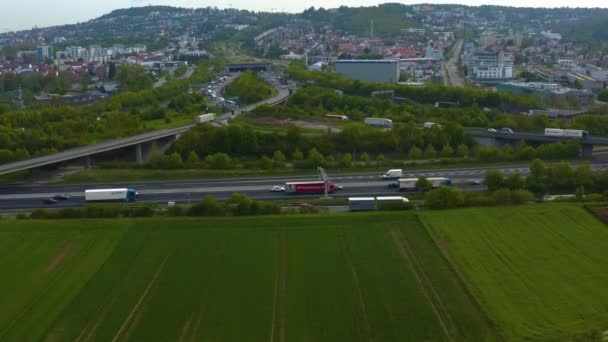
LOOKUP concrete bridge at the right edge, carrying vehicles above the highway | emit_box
[465,129,608,158]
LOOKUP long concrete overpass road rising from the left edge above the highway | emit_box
[0,88,290,175]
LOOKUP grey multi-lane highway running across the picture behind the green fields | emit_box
[0,163,608,210]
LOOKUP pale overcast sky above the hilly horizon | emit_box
[0,0,608,32]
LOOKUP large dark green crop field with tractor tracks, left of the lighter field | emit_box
[0,213,494,342]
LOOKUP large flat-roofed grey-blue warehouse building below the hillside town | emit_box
[336,59,399,83]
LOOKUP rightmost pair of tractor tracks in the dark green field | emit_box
[391,229,454,341]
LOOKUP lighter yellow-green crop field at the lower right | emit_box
[421,205,608,341]
